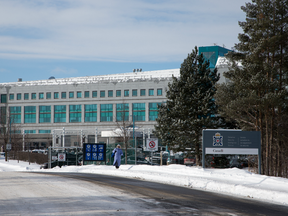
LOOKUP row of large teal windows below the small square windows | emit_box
[5,103,161,123]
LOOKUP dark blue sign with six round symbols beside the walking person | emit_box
[83,143,106,163]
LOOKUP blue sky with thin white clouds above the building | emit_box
[0,0,249,83]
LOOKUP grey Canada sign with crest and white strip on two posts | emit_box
[202,129,261,174]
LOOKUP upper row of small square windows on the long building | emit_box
[1,88,163,103]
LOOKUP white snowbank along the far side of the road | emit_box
[0,157,288,205]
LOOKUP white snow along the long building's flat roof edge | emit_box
[0,69,180,86]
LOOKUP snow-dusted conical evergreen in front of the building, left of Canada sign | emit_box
[155,47,221,165]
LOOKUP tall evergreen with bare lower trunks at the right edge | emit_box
[215,0,288,175]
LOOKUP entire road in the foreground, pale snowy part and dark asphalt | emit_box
[0,172,288,216]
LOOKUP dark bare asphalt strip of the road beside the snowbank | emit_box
[41,173,288,216]
